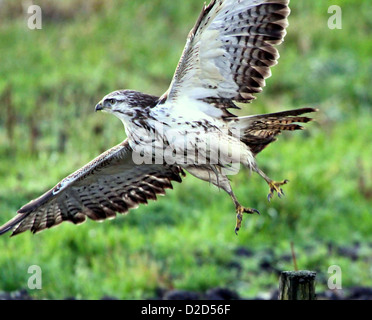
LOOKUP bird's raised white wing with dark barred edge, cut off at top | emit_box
[163,0,290,117]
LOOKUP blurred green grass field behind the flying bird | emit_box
[0,0,372,299]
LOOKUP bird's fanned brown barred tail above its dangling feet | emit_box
[229,108,318,155]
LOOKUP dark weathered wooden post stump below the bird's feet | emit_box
[279,270,316,300]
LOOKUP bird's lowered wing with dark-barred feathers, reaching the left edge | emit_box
[0,140,184,235]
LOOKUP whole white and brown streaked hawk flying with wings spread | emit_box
[0,0,316,235]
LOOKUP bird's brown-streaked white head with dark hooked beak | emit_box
[95,90,158,121]
